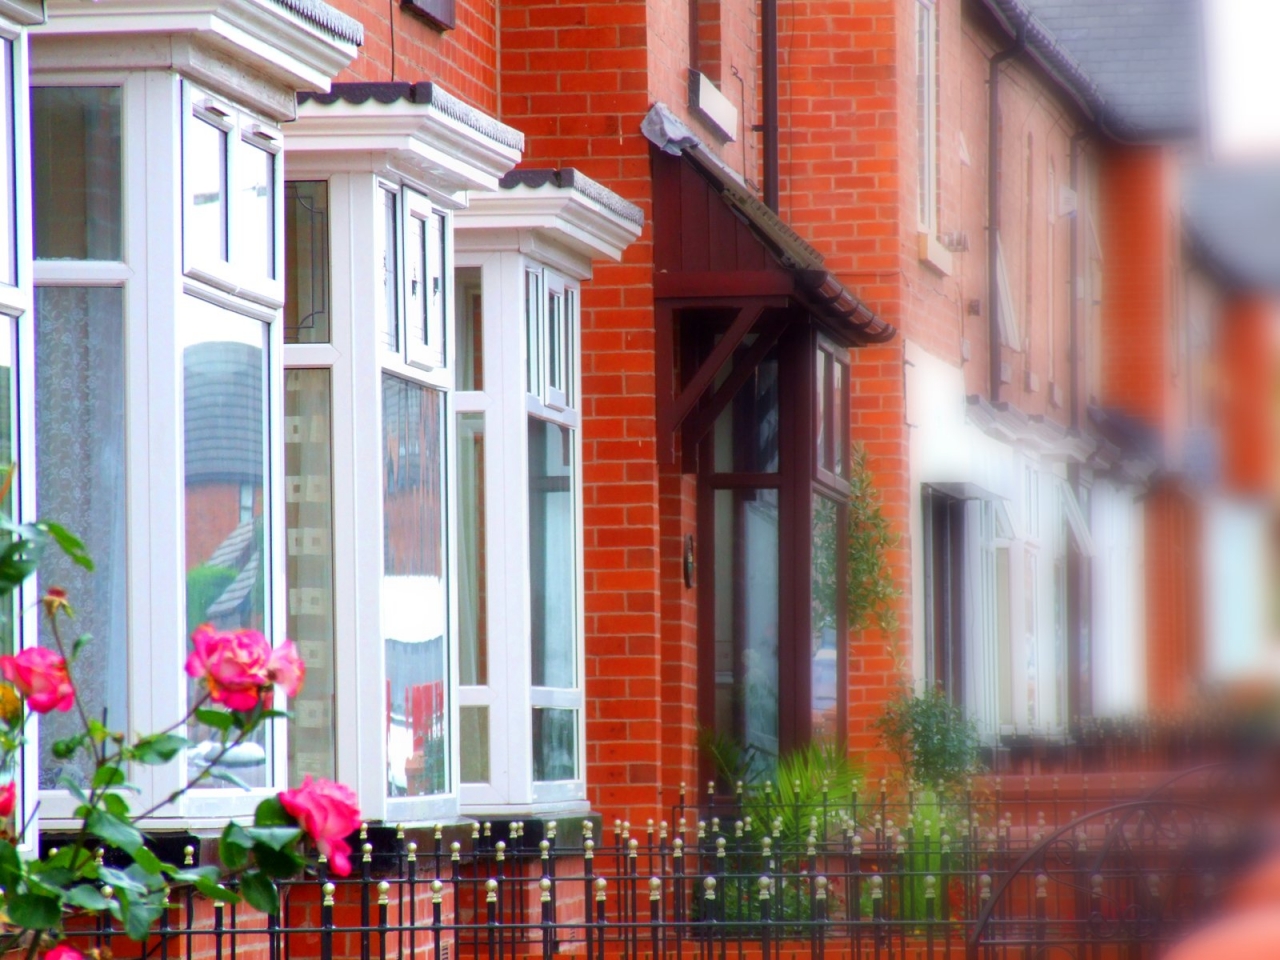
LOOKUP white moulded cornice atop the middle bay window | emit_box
[284,99,520,209]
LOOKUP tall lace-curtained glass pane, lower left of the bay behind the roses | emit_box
[34,293,129,787]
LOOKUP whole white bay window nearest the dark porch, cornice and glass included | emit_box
[453,170,643,815]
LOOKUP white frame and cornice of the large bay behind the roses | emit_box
[22,0,355,829]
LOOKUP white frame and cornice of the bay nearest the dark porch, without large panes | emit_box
[454,183,640,815]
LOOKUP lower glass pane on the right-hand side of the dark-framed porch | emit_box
[809,497,845,740]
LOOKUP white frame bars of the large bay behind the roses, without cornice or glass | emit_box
[23,70,287,829]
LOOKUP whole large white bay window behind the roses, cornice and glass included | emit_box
[26,0,360,829]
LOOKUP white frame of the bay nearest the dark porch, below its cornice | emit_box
[454,250,586,814]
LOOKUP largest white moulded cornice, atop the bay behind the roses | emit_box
[31,0,357,109]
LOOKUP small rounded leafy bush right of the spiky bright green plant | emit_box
[876,687,982,796]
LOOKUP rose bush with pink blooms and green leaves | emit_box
[0,519,360,960]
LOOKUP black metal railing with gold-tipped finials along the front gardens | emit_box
[64,796,1248,960]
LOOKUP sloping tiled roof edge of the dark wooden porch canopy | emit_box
[640,102,897,343]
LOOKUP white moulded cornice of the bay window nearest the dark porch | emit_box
[453,184,641,279]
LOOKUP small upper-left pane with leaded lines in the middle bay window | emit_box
[284,180,330,343]
